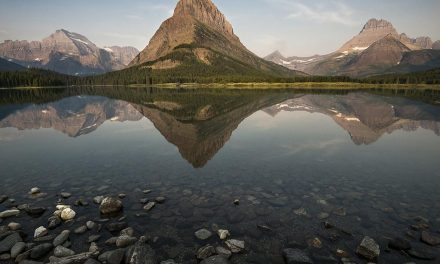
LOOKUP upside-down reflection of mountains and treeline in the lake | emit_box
[0,89,440,168]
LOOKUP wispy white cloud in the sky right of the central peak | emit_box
[272,0,357,26]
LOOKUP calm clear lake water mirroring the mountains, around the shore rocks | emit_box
[0,88,440,263]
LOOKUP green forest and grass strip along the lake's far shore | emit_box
[0,64,440,89]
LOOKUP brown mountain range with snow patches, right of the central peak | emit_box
[265,19,440,77]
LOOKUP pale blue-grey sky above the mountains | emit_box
[0,0,440,56]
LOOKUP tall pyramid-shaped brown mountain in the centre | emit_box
[130,0,300,76]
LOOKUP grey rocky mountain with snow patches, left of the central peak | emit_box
[0,29,135,75]
